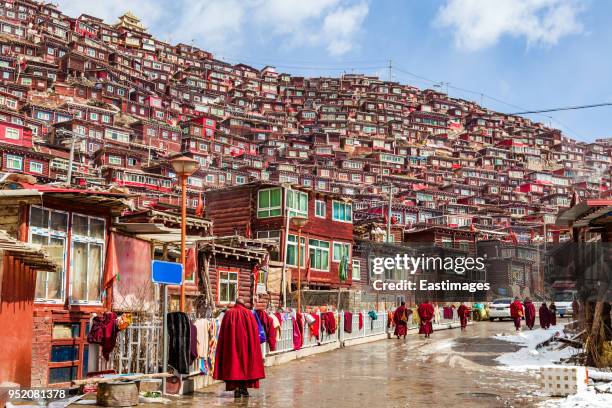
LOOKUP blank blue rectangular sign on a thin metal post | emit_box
[151,261,183,394]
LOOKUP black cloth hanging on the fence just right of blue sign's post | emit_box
[167,312,191,374]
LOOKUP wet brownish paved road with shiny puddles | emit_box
[180,322,538,408]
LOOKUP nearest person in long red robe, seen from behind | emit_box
[213,299,266,397]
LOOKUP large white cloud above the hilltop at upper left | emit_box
[58,0,369,56]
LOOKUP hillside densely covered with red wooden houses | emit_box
[0,0,612,386]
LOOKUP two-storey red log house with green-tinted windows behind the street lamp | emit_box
[205,182,353,289]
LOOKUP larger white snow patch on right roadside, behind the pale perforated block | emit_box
[495,325,577,371]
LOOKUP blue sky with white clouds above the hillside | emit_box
[59,0,612,141]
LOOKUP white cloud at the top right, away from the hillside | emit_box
[434,0,583,51]
